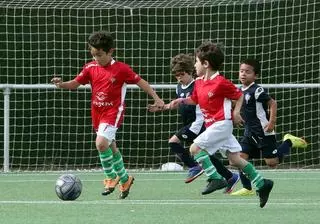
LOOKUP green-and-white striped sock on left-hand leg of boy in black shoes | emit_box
[194,151,222,179]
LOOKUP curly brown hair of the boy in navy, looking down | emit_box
[170,54,194,75]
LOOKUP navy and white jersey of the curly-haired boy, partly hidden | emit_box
[176,80,203,134]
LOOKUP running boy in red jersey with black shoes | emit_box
[170,42,273,208]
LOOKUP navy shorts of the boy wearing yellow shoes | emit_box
[240,135,278,159]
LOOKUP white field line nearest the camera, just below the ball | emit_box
[0,199,320,207]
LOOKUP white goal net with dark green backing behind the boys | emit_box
[0,0,320,171]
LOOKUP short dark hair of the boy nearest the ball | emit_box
[88,31,114,52]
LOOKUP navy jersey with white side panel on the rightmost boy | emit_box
[241,83,275,137]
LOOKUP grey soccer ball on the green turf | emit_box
[55,174,82,201]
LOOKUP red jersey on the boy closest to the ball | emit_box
[75,60,141,130]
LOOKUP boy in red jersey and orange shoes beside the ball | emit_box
[51,31,164,199]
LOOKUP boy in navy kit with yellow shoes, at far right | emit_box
[231,59,307,196]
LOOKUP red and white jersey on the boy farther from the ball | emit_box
[191,73,242,127]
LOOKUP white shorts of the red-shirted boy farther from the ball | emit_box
[193,120,241,155]
